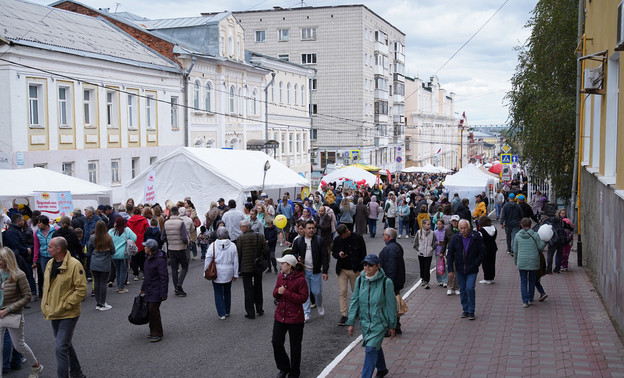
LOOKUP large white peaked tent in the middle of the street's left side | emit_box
[126,147,309,215]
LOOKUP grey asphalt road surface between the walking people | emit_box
[13,226,419,378]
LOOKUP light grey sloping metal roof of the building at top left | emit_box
[0,0,179,72]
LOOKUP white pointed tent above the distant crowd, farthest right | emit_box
[444,164,498,210]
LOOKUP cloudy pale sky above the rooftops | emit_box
[35,0,537,125]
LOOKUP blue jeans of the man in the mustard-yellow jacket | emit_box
[52,317,82,378]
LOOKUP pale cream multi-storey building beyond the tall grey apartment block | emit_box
[405,76,456,169]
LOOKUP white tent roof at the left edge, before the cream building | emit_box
[0,168,111,210]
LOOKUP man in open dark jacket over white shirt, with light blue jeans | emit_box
[292,220,329,322]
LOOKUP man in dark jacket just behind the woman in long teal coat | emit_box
[379,227,405,335]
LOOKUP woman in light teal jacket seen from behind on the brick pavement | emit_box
[511,218,544,308]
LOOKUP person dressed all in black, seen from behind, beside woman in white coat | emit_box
[236,219,269,319]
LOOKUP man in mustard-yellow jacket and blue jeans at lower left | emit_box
[41,237,87,377]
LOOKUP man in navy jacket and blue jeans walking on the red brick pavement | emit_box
[447,219,485,320]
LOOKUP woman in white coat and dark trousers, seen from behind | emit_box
[204,227,238,320]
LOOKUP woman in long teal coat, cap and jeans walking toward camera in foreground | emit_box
[346,255,397,378]
